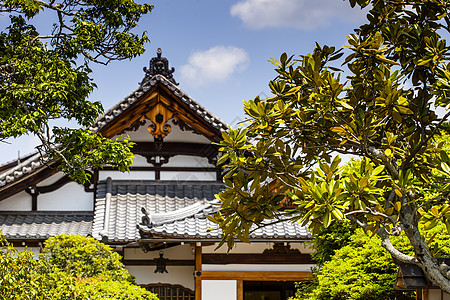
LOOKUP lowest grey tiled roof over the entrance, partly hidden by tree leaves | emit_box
[139,204,311,240]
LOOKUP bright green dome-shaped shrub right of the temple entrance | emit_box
[301,230,415,300]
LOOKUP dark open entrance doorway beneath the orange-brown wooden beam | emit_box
[244,281,295,300]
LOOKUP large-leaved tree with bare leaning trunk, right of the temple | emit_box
[215,0,450,292]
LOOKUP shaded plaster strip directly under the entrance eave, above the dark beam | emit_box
[202,242,313,254]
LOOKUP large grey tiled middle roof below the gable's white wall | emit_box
[92,181,223,242]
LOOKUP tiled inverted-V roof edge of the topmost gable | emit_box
[90,74,228,132]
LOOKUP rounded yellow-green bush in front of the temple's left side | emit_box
[0,235,157,300]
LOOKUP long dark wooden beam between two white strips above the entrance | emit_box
[202,253,315,265]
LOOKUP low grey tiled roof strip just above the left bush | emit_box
[0,211,93,240]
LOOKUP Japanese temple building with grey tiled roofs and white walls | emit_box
[0,49,314,300]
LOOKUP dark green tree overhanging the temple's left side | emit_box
[0,0,152,182]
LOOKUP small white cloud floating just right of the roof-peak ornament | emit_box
[180,46,250,86]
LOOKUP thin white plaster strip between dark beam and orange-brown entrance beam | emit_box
[202,264,315,272]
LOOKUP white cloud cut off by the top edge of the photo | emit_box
[230,0,365,30]
